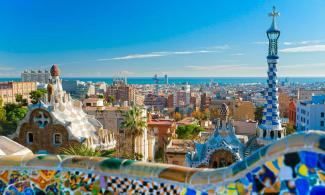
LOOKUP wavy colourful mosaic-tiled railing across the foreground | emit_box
[0,131,325,194]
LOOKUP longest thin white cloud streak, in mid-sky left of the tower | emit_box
[97,45,229,61]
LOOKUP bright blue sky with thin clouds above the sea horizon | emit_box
[0,0,325,77]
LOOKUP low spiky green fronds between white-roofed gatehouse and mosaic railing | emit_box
[59,144,115,157]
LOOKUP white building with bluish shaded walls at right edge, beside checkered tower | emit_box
[296,95,325,131]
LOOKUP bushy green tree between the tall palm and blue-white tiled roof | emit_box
[176,124,204,139]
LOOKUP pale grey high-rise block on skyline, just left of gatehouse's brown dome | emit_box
[21,70,51,83]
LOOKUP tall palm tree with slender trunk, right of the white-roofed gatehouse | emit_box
[121,106,147,159]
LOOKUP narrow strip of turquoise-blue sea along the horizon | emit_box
[0,77,325,85]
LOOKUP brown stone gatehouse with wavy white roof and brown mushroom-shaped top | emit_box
[11,65,116,154]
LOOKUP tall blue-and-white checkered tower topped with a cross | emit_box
[258,7,284,145]
